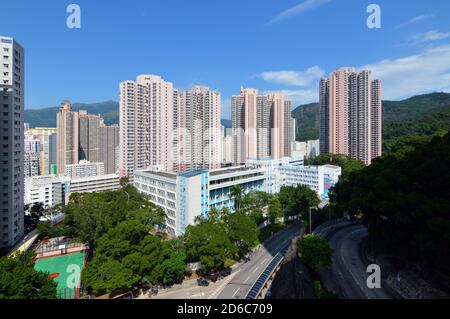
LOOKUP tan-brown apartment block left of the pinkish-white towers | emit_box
[56,101,119,174]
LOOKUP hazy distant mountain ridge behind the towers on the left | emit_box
[25,101,231,127]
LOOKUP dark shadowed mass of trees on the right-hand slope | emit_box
[331,134,450,273]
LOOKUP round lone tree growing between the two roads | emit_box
[297,235,333,272]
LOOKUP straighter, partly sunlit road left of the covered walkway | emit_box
[217,222,301,299]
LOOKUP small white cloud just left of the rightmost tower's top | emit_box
[259,66,325,86]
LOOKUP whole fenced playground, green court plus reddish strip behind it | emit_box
[34,238,87,299]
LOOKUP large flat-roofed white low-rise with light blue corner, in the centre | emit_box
[134,166,265,236]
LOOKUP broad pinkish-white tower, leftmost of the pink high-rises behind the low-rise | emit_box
[119,75,177,178]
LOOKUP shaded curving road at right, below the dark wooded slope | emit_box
[320,225,392,299]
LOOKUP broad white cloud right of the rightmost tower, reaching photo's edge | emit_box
[359,45,450,100]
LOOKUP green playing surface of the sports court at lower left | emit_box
[34,252,84,299]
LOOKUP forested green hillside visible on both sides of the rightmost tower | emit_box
[292,93,450,150]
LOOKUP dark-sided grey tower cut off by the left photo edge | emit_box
[0,36,25,250]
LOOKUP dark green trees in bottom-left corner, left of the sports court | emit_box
[0,253,56,299]
